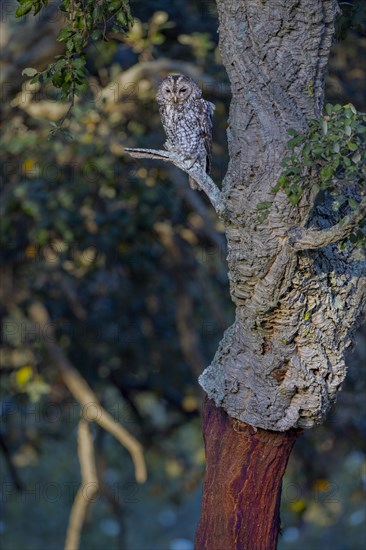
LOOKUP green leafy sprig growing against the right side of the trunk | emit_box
[257,103,366,248]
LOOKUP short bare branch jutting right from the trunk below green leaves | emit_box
[289,198,366,250]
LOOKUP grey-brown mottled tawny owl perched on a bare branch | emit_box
[156,74,215,189]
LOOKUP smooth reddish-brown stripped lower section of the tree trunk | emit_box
[195,399,301,550]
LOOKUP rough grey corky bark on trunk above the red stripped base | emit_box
[200,0,366,431]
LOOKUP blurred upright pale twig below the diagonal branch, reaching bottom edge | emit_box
[65,418,98,550]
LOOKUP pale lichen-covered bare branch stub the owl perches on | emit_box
[125,147,224,217]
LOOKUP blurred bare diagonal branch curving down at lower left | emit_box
[29,302,146,483]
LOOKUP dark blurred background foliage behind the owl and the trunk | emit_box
[0,0,366,550]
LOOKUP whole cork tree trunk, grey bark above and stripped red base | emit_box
[196,0,366,550]
